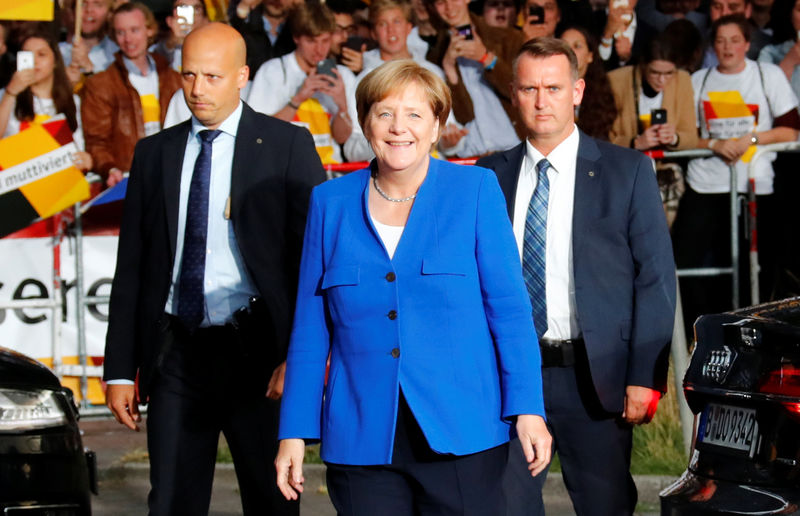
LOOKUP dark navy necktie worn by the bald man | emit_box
[178,130,220,331]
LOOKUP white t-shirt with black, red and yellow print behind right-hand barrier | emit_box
[687,59,797,195]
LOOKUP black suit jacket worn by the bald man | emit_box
[104,104,325,400]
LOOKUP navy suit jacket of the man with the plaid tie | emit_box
[478,133,676,412]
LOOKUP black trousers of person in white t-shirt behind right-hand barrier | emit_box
[672,187,778,335]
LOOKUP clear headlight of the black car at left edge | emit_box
[0,388,68,432]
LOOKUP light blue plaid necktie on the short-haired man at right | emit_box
[522,159,550,340]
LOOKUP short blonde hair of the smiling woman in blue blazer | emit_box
[356,59,453,135]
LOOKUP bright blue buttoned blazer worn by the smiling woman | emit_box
[279,159,544,465]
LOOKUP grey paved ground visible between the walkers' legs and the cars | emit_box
[81,419,672,516]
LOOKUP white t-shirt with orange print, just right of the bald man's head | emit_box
[247,52,358,164]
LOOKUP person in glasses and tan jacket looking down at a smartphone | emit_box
[608,37,697,150]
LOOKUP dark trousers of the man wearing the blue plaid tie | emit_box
[503,349,638,516]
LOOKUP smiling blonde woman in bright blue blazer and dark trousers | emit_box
[276,60,551,515]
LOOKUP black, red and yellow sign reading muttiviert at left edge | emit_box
[0,116,89,238]
